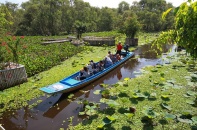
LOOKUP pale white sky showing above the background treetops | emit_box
[0,0,192,8]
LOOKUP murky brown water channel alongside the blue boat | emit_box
[0,45,174,130]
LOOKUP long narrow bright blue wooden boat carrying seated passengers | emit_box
[40,52,134,94]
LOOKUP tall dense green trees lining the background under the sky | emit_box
[0,0,173,35]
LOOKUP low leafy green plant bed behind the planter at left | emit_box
[0,35,89,76]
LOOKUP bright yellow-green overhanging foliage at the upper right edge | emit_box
[155,0,197,57]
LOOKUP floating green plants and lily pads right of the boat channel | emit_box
[74,49,197,129]
